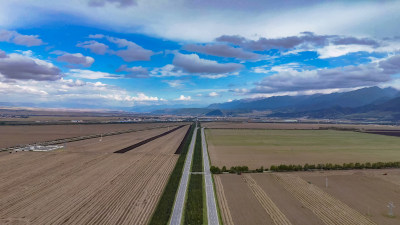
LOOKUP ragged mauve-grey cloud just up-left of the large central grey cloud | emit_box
[107,37,154,62]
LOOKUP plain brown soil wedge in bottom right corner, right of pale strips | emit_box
[299,169,400,225]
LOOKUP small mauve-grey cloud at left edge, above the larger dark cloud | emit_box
[0,30,45,47]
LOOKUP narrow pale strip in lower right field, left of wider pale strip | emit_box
[242,174,292,225]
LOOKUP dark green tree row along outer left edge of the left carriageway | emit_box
[149,125,194,225]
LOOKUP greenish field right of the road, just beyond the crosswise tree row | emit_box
[206,129,400,169]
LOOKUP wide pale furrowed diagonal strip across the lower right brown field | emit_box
[275,174,375,225]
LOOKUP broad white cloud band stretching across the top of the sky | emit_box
[0,0,400,42]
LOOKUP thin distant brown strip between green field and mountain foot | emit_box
[201,122,400,130]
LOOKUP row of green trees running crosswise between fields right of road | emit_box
[210,162,400,174]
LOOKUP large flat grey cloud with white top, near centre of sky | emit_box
[172,53,243,74]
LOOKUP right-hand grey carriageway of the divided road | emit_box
[201,128,219,225]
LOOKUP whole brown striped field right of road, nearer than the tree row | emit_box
[214,169,400,225]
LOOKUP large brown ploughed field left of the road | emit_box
[0,126,189,224]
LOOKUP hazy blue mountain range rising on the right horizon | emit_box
[153,87,400,121]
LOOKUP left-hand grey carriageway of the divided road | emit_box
[169,126,197,225]
